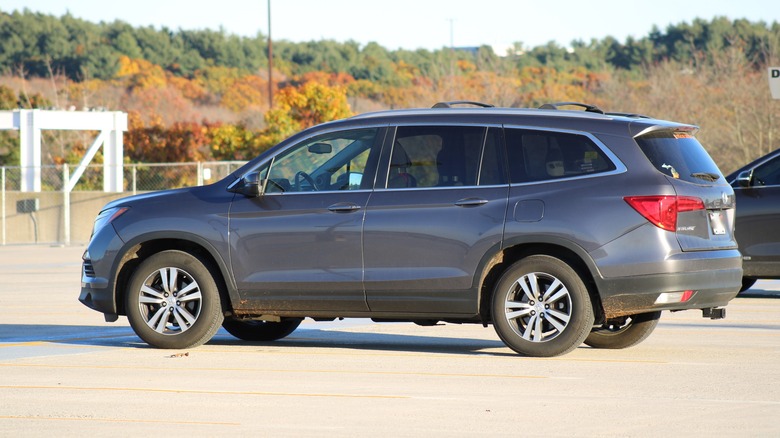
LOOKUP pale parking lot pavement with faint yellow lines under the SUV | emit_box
[0,246,780,437]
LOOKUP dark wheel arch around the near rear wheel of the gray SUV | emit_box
[479,239,604,325]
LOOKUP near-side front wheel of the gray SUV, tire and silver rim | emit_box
[125,251,223,349]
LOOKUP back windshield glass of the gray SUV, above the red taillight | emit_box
[636,131,723,184]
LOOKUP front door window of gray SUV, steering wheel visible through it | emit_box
[263,128,378,193]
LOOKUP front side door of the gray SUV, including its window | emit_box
[230,128,384,311]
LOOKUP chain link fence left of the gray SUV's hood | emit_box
[0,161,245,245]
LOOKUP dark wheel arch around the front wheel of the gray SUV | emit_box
[113,232,237,315]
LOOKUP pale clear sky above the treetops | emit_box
[0,0,780,54]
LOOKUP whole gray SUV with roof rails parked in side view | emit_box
[79,102,742,356]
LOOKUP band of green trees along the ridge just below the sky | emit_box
[0,9,780,85]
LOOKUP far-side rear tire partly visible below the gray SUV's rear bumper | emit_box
[585,312,661,350]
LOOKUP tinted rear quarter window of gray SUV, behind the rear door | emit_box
[504,129,615,183]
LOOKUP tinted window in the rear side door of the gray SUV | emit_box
[387,126,490,188]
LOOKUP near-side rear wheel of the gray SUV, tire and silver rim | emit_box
[492,255,593,357]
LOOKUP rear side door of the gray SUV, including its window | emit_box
[363,125,509,314]
